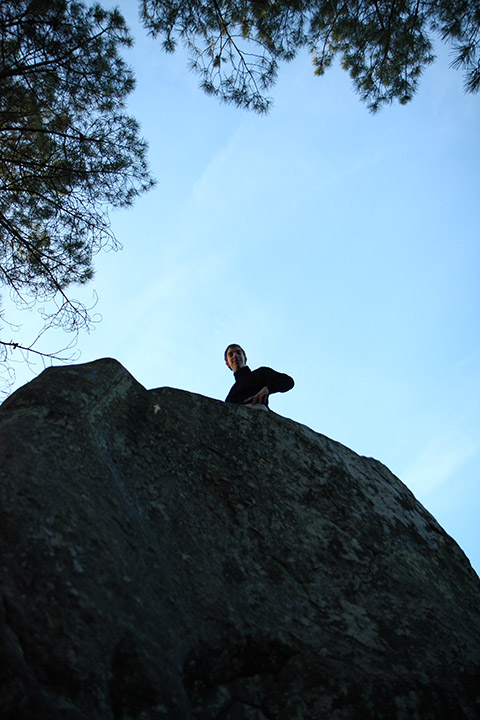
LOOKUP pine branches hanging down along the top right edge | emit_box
[142,0,480,112]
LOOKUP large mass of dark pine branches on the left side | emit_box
[0,0,152,372]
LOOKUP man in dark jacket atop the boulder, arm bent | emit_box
[225,344,295,408]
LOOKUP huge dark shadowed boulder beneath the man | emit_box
[0,359,480,720]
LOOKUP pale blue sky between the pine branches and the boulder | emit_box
[4,2,480,573]
